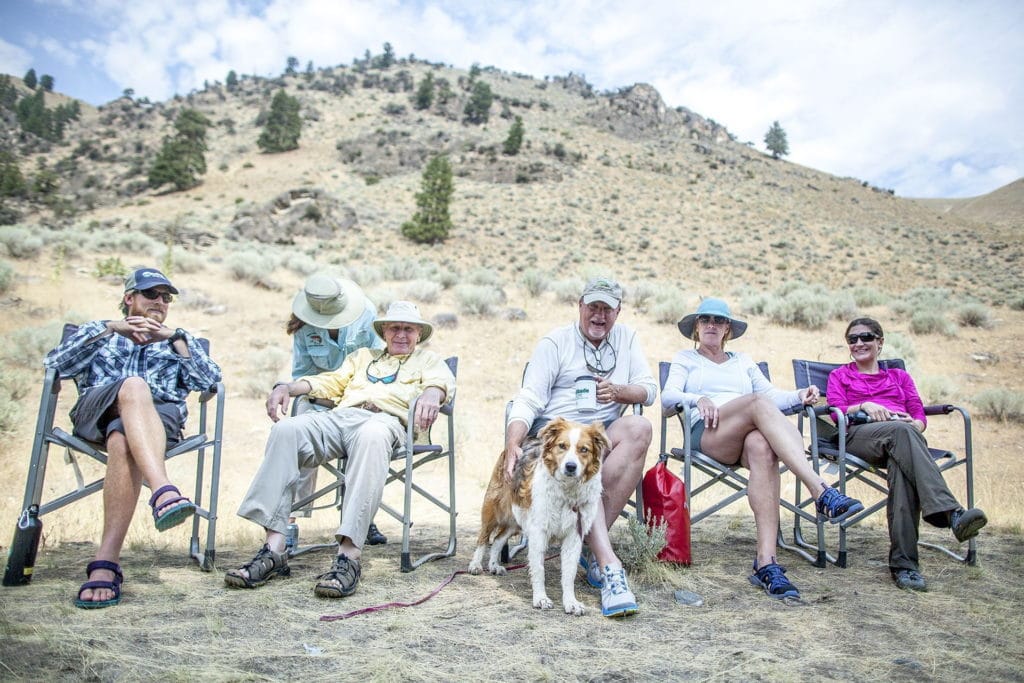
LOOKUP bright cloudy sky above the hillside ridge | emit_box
[0,0,1024,197]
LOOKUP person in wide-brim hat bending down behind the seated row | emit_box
[284,274,387,545]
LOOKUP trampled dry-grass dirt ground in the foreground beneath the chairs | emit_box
[0,514,1024,681]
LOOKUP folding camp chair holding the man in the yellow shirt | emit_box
[282,356,459,571]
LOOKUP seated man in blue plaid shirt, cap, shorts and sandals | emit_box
[43,268,220,608]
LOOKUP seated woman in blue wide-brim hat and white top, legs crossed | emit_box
[662,298,863,599]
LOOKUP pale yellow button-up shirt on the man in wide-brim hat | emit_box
[302,348,455,425]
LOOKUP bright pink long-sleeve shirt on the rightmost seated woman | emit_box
[825,362,928,425]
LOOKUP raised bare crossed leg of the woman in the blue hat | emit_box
[700,394,824,500]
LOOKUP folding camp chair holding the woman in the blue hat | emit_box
[657,360,825,567]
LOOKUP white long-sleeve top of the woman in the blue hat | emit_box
[662,349,801,426]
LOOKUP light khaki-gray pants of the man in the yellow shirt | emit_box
[239,408,406,548]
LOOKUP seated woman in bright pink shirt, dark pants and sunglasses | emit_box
[825,317,988,591]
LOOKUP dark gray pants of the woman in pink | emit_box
[847,421,959,570]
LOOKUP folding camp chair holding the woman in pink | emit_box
[793,358,977,567]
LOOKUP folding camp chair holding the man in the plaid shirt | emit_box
[12,325,225,571]
